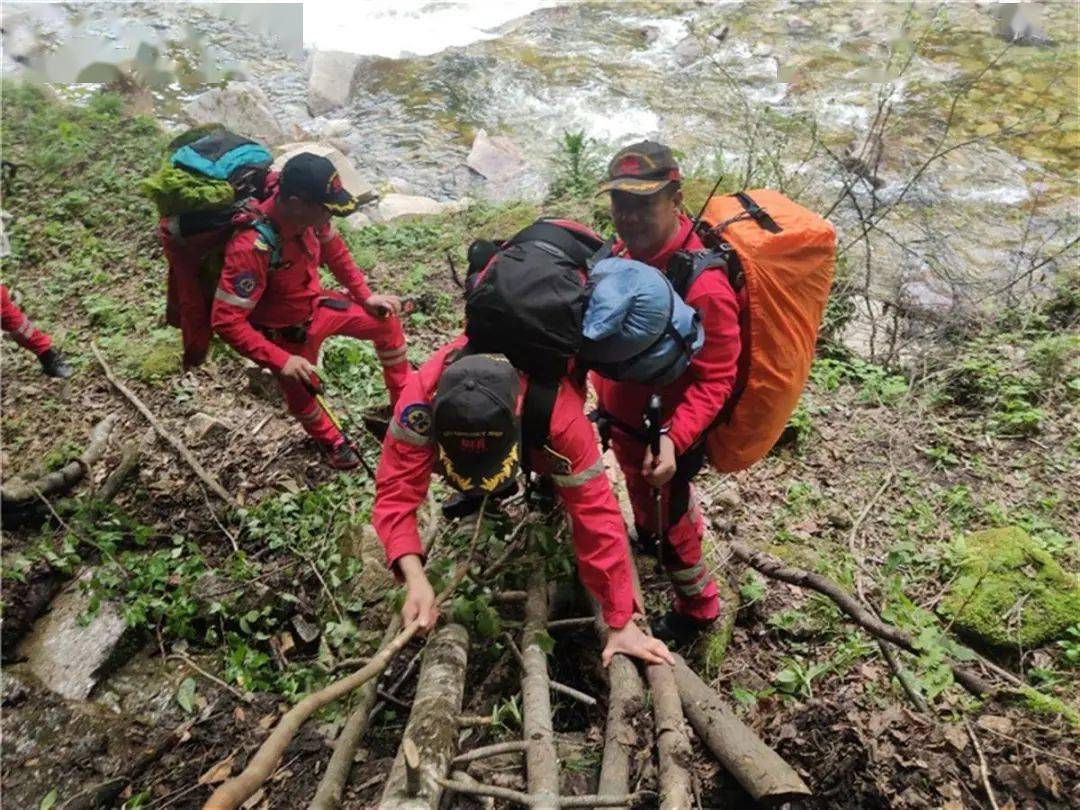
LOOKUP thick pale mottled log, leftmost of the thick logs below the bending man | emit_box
[379,624,469,810]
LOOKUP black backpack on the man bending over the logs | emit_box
[465,219,604,379]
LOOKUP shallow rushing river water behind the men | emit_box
[4,0,1080,345]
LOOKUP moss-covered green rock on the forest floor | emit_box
[942,526,1080,649]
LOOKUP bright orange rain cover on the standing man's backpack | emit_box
[702,189,836,472]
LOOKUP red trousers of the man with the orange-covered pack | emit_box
[611,438,720,621]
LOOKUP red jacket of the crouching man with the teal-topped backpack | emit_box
[212,193,372,372]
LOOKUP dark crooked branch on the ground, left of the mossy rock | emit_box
[728,540,995,698]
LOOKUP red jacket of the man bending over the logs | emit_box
[372,336,636,629]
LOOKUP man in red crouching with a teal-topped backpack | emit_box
[212,152,409,470]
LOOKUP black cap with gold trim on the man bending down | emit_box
[432,354,522,494]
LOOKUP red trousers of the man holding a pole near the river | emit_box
[274,293,409,446]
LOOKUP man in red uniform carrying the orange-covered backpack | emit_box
[592,141,743,642]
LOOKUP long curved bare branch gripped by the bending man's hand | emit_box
[203,507,487,810]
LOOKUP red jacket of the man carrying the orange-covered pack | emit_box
[592,215,745,454]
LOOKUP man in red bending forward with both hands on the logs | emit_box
[372,337,672,665]
